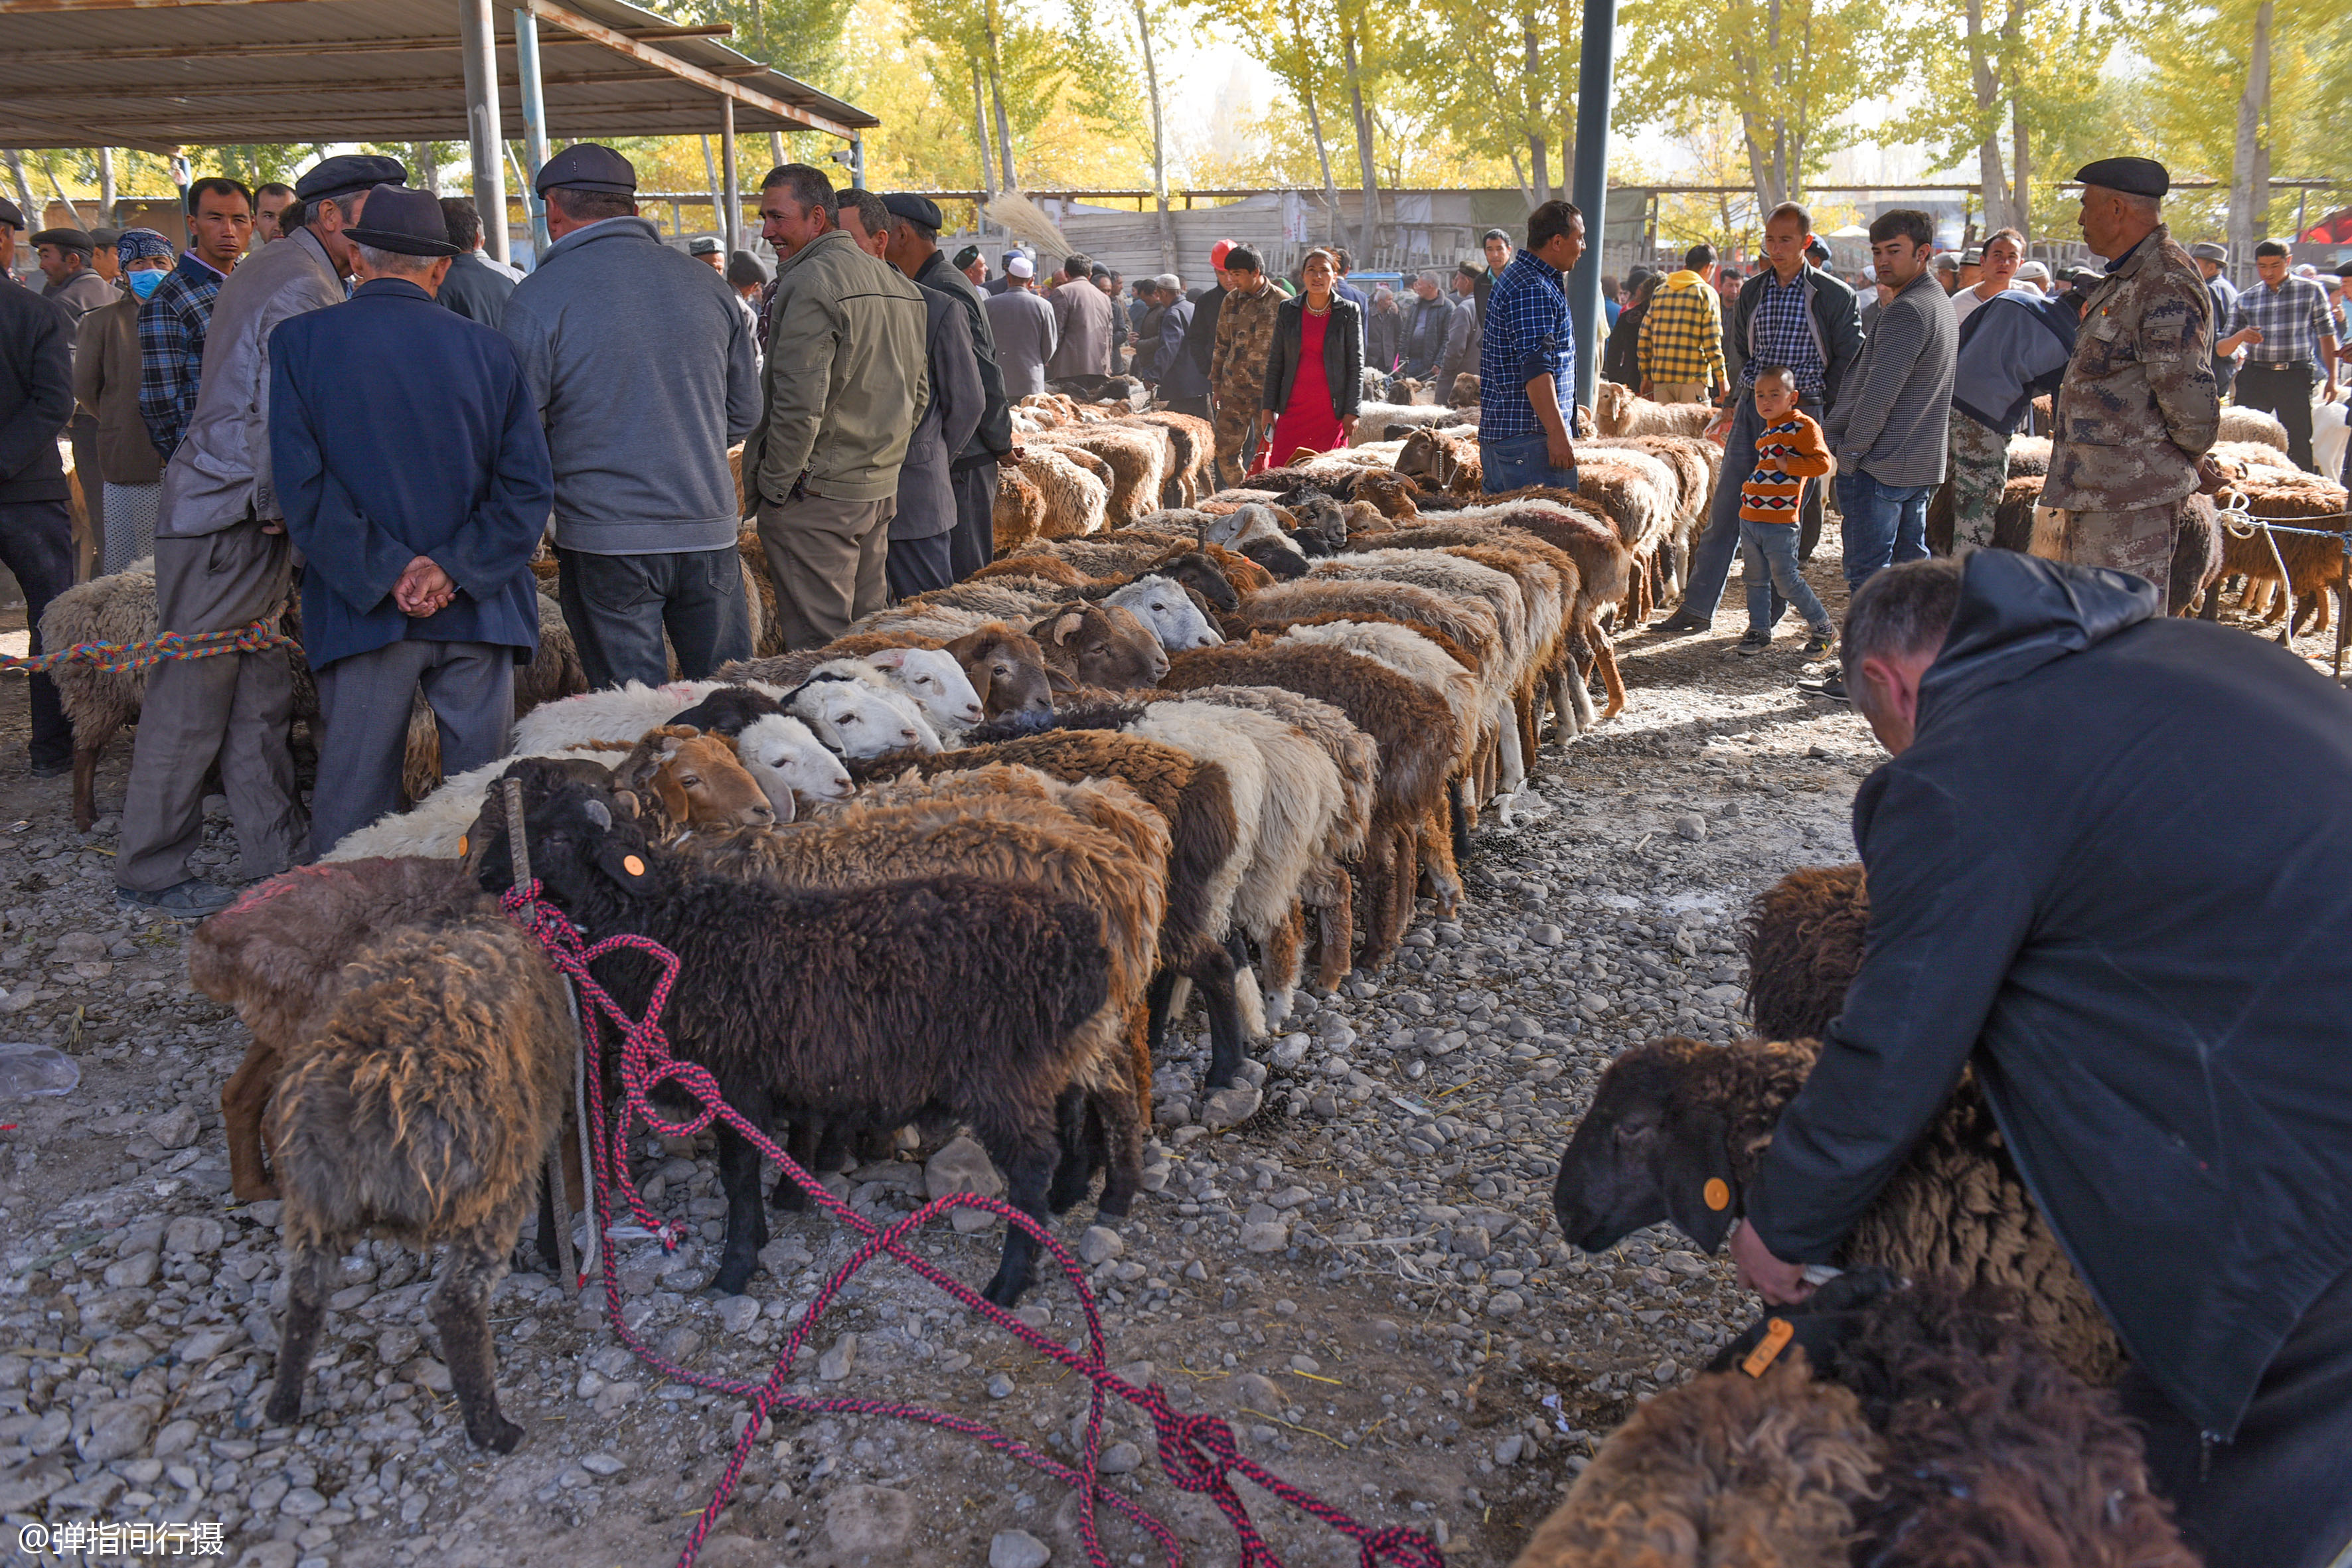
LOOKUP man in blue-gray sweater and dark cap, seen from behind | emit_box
[499,141,759,686]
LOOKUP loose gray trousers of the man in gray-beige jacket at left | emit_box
[116,520,303,894]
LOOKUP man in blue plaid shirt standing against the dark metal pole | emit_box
[1477,202,1585,496]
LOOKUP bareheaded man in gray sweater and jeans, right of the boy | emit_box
[1820,209,1959,698]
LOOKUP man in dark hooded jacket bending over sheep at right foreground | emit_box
[1731,550,2352,1568]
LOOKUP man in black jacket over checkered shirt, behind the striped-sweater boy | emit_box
[1654,202,1863,637]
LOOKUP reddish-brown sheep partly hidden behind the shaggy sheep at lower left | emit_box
[188,860,505,1204]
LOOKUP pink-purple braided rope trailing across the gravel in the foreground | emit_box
[501,879,1444,1568]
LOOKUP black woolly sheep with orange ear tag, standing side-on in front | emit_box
[480,764,1110,1307]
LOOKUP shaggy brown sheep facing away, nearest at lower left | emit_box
[266,912,579,1452]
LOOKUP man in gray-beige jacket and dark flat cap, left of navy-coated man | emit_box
[116,153,409,919]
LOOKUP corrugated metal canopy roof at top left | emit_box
[0,0,880,153]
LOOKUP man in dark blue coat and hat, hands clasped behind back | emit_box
[270,186,555,853]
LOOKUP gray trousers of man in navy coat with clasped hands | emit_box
[311,639,515,856]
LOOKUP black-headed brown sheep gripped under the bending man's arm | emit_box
[1552,1039,2124,1385]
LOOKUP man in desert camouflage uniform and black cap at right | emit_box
[2041,157,2221,611]
